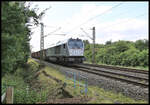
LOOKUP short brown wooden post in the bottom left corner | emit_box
[6,87,13,104]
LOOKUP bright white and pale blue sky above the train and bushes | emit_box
[27,1,148,52]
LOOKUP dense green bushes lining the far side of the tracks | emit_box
[84,39,148,67]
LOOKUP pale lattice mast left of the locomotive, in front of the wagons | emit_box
[40,23,44,63]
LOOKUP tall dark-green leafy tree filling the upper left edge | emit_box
[1,1,48,74]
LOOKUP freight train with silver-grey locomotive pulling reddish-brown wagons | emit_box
[31,38,85,63]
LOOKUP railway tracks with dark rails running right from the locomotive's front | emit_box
[71,64,149,88]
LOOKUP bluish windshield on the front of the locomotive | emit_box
[68,39,83,49]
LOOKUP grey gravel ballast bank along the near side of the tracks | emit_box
[36,60,149,101]
